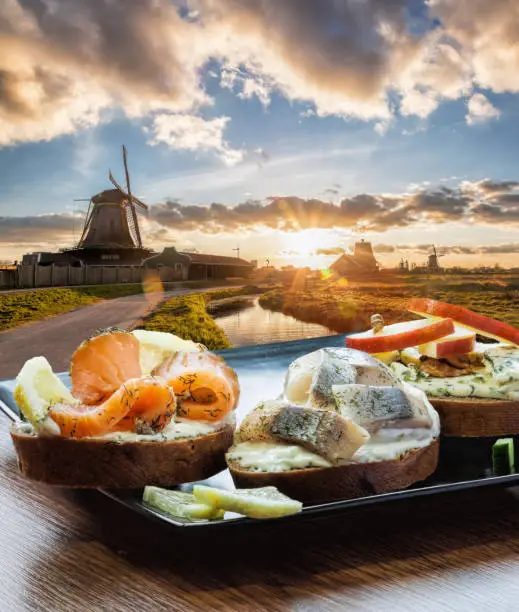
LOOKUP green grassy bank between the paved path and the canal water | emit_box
[139,286,261,350]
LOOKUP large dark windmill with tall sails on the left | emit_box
[77,145,148,249]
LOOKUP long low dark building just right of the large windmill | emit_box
[143,247,255,282]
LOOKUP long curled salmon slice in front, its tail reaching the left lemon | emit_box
[49,376,175,438]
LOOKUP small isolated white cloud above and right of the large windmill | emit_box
[149,114,244,166]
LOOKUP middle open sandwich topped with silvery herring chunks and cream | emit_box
[226,347,440,502]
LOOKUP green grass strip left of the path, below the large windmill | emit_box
[0,281,250,331]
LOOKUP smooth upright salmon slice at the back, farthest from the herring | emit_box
[70,329,142,405]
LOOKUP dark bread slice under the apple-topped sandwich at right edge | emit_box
[429,397,519,438]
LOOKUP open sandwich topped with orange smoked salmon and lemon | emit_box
[11,329,239,488]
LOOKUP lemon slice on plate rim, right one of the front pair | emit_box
[193,485,303,518]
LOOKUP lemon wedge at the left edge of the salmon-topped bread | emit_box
[14,357,77,434]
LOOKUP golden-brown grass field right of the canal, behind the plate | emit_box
[260,275,519,333]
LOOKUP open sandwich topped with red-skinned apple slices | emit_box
[346,298,519,437]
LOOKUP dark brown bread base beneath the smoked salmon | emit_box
[11,424,234,489]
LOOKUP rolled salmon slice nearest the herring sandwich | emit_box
[154,351,239,421]
